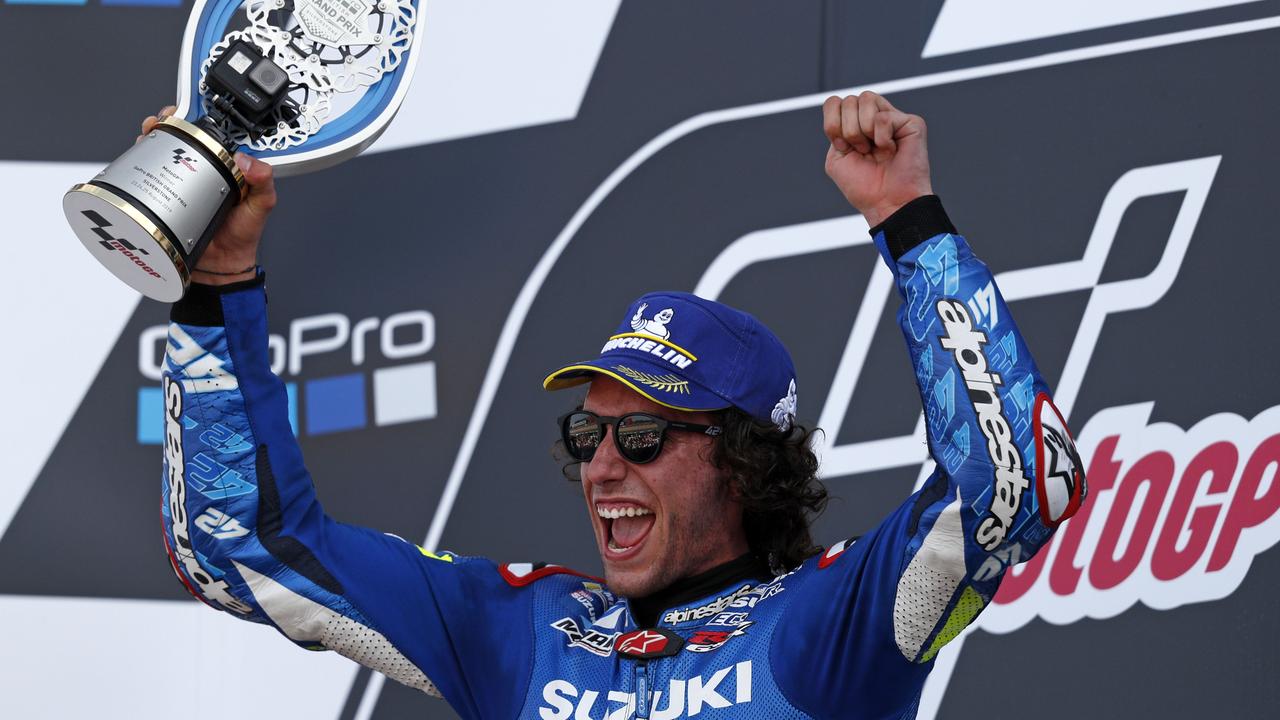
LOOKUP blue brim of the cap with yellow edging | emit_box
[543,356,732,413]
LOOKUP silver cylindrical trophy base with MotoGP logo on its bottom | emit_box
[63,118,246,302]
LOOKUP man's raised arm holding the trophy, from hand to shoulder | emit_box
[143,107,532,717]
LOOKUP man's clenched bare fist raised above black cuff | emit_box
[822,91,933,227]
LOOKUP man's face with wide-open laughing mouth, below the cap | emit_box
[582,375,748,597]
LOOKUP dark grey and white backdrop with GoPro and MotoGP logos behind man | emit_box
[0,0,1280,720]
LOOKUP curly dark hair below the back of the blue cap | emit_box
[710,407,827,573]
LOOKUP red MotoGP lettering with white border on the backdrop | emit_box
[980,402,1280,632]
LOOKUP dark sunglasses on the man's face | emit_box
[559,410,723,465]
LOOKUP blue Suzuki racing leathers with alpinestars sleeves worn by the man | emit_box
[154,196,1084,720]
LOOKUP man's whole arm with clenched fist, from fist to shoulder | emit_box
[776,92,1085,717]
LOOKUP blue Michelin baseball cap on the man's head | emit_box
[543,292,796,430]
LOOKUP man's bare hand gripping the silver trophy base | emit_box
[138,105,275,284]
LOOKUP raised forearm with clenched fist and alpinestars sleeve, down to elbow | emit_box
[823,92,1085,576]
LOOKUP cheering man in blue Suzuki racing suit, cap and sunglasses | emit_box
[154,92,1085,720]
